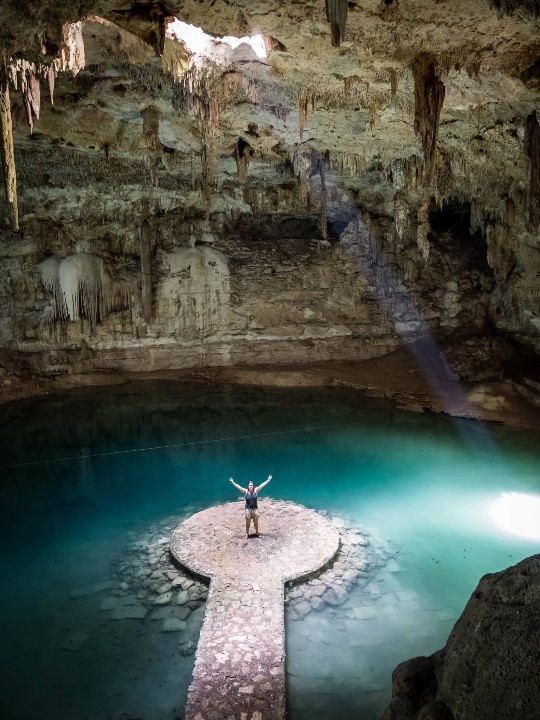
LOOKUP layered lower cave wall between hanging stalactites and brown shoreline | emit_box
[0,176,493,373]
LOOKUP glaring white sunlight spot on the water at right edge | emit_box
[489,492,540,541]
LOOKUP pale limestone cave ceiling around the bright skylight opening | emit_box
[0,0,540,236]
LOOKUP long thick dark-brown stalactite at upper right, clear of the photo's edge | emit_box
[413,53,445,185]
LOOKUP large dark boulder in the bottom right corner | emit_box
[382,555,540,720]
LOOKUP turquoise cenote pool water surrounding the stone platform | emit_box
[0,383,540,720]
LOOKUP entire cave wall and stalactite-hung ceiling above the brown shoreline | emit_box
[0,0,540,388]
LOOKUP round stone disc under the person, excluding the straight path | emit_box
[171,499,339,583]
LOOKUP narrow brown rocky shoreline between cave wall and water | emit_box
[0,350,540,429]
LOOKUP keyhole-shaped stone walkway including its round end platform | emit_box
[171,499,340,720]
